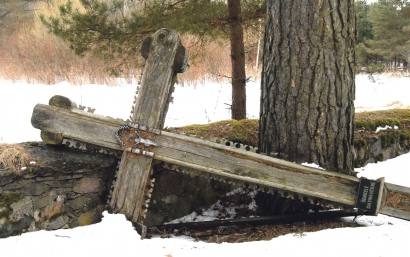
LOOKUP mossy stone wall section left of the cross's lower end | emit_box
[0,143,118,238]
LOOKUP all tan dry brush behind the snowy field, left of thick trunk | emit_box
[0,0,259,84]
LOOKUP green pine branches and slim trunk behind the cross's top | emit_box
[42,0,265,119]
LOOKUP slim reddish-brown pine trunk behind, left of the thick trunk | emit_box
[228,0,246,120]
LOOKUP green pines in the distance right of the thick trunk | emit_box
[356,0,410,72]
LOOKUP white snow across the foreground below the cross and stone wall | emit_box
[0,206,410,257]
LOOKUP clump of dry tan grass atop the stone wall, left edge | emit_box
[0,144,30,172]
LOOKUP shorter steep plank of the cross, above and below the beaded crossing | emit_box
[110,29,187,222]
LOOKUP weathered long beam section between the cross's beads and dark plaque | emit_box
[154,132,358,206]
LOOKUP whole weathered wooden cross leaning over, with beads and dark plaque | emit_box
[32,29,410,234]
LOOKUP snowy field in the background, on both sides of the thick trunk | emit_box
[0,75,410,143]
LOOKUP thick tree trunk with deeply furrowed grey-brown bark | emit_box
[259,0,355,173]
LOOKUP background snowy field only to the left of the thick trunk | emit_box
[0,79,260,143]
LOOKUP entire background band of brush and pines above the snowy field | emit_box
[0,0,410,83]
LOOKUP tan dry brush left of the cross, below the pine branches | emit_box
[0,24,127,84]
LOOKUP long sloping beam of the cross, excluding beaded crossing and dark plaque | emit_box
[32,104,410,220]
